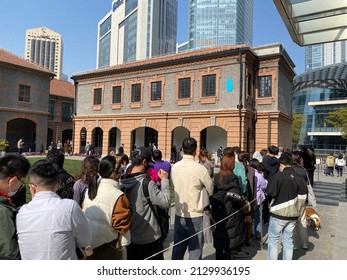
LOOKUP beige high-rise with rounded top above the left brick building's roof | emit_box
[24,27,64,80]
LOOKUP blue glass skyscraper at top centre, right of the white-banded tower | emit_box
[188,0,253,50]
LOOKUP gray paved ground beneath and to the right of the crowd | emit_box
[164,167,347,260]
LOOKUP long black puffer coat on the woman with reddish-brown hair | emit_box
[210,173,245,249]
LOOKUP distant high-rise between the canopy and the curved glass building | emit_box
[305,41,347,72]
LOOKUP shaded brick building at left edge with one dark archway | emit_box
[0,49,54,152]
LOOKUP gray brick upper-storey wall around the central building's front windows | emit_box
[77,60,240,115]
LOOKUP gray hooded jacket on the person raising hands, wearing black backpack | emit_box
[120,173,170,244]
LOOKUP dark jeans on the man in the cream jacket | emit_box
[171,215,204,260]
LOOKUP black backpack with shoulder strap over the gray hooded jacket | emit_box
[142,178,170,239]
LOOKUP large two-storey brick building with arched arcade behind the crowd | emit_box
[72,44,295,159]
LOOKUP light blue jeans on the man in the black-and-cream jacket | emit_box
[267,216,297,260]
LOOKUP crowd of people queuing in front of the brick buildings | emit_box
[0,141,346,260]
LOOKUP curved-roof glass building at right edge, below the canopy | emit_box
[293,63,347,152]
